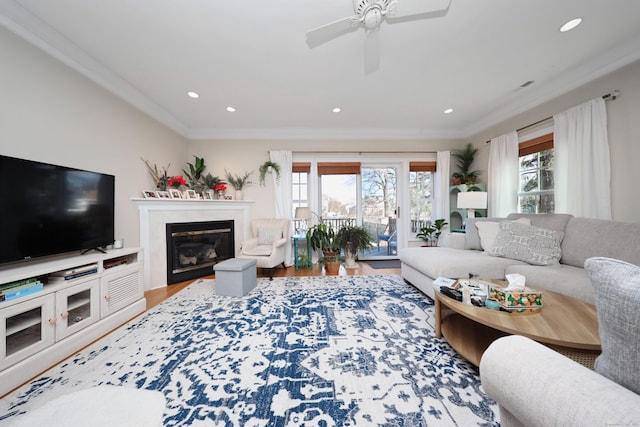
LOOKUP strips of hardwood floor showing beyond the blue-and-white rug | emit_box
[144,262,400,310]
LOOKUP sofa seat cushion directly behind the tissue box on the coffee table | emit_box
[505,264,595,304]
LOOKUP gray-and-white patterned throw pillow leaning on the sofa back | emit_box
[488,221,564,265]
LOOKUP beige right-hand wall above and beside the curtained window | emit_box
[469,61,640,221]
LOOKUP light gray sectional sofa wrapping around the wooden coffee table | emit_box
[400,214,640,427]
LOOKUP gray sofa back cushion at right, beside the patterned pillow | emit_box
[562,218,640,267]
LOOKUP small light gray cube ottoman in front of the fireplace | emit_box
[213,258,257,297]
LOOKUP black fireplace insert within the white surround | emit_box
[166,220,235,284]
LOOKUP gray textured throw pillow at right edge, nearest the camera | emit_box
[584,257,640,394]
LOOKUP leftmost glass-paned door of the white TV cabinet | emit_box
[0,295,56,369]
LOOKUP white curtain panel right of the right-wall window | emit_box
[553,98,611,219]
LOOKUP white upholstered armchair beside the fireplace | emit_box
[238,218,291,279]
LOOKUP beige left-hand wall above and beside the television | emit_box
[0,28,187,246]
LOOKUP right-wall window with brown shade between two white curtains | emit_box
[518,133,555,213]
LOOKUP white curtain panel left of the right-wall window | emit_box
[487,131,520,217]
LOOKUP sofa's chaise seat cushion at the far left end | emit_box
[399,247,524,279]
